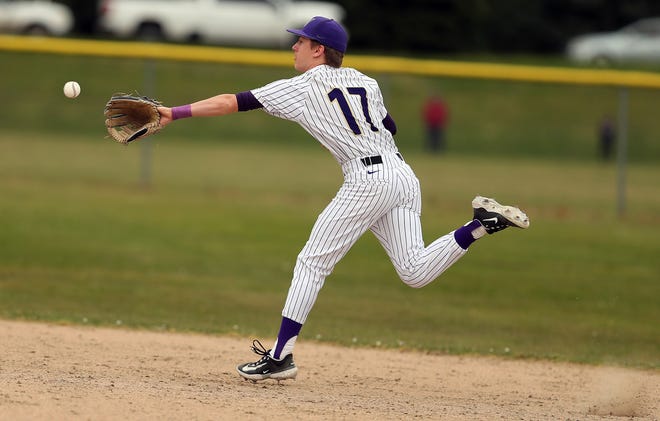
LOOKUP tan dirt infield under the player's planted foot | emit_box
[0,320,660,420]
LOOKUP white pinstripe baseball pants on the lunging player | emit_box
[282,154,466,324]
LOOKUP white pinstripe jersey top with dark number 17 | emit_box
[252,65,398,164]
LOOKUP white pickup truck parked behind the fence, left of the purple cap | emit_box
[99,0,345,47]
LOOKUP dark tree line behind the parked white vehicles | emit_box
[59,0,660,54]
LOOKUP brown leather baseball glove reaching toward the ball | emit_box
[103,94,161,144]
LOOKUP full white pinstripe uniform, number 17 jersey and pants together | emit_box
[252,65,465,324]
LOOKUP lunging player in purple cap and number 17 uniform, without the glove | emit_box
[158,16,529,381]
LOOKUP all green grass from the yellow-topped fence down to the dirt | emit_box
[0,53,660,369]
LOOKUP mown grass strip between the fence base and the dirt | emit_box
[0,132,660,367]
